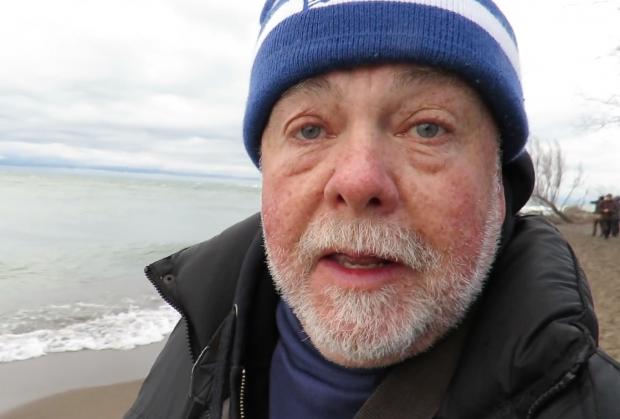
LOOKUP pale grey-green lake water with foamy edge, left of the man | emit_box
[0,166,260,362]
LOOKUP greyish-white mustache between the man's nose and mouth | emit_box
[296,216,440,272]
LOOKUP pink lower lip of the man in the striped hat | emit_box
[312,258,407,290]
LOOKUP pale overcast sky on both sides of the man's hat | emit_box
[0,0,620,195]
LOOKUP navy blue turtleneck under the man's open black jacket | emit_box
[269,301,385,419]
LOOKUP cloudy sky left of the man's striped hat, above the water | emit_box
[0,0,260,176]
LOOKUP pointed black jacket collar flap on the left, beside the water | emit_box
[145,214,266,360]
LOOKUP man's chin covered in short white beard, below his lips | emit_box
[286,279,474,368]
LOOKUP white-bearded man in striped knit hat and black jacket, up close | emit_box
[126,0,620,419]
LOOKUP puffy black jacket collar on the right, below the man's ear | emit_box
[439,217,598,418]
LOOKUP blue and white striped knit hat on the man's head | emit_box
[243,0,528,166]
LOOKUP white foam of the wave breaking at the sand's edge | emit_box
[0,306,179,362]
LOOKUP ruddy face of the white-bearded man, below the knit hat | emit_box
[261,65,505,367]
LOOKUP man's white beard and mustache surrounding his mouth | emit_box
[265,176,503,367]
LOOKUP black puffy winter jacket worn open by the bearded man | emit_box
[125,215,620,419]
